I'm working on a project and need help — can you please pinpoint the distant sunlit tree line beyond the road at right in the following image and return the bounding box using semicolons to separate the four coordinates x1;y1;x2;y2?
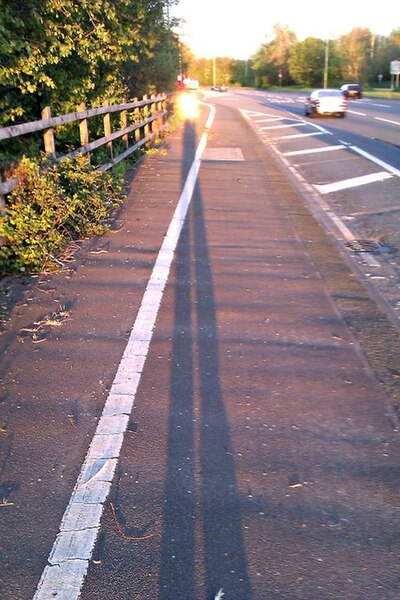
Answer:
189;24;400;88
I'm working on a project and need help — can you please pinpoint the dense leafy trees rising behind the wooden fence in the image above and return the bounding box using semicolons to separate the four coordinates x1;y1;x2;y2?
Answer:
0;0;179;126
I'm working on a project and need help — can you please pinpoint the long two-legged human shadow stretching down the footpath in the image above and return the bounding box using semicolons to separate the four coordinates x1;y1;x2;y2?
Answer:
159;122;253;600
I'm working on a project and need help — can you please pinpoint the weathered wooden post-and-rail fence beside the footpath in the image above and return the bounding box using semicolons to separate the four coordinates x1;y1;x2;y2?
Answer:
0;94;167;214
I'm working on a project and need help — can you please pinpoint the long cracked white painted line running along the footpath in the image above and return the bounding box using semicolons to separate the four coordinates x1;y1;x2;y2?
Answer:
34;105;215;600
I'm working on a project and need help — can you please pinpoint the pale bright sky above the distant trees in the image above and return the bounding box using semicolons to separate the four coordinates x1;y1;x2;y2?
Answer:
171;0;400;59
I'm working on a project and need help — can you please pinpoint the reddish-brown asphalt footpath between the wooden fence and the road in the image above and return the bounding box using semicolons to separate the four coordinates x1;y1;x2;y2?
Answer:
0;99;400;600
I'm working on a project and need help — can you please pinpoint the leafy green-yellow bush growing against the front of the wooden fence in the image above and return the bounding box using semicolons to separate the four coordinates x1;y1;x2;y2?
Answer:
0;154;123;275
